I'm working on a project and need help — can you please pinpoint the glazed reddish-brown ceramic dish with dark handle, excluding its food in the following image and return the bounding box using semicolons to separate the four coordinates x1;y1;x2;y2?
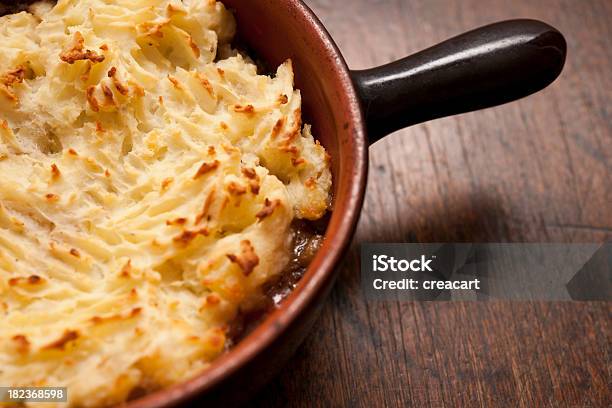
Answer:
119;0;566;408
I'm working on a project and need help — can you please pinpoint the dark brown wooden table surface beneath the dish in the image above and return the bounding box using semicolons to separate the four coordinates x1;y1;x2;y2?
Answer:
253;0;612;407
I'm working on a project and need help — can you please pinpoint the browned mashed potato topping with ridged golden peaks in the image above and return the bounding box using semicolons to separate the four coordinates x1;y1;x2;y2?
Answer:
0;0;331;406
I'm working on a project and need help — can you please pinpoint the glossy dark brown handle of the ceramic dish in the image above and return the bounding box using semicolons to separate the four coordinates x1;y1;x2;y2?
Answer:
351;20;567;143
